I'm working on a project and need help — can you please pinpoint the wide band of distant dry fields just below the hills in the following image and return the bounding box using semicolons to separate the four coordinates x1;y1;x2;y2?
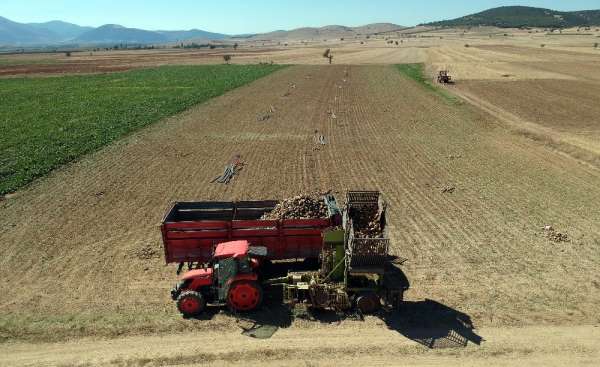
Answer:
0;27;600;75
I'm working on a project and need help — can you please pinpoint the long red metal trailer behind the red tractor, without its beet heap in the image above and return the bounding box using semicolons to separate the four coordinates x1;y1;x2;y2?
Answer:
161;196;342;264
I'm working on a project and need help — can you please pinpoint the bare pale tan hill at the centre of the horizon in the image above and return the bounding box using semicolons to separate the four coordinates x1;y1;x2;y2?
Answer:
250;23;406;40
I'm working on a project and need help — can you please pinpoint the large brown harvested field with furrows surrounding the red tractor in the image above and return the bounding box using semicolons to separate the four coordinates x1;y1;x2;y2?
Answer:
0;65;600;364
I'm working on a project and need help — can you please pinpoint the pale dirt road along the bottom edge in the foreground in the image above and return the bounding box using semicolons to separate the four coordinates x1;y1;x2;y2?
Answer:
0;325;600;367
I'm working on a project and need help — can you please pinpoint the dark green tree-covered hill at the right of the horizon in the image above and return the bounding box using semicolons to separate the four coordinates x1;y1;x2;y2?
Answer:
425;6;600;28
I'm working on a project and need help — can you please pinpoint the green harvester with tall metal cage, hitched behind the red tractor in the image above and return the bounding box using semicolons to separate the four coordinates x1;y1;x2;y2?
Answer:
271;191;406;313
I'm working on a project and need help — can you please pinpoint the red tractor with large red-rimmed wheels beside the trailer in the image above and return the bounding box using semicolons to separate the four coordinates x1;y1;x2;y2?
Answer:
171;241;267;317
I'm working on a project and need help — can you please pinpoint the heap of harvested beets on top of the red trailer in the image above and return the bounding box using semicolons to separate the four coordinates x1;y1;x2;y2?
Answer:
262;195;327;220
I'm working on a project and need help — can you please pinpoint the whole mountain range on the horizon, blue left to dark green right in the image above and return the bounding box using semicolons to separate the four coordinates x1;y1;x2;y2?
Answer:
0;6;600;47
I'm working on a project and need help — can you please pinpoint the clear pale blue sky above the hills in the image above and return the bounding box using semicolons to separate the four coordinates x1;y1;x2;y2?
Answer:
0;0;600;34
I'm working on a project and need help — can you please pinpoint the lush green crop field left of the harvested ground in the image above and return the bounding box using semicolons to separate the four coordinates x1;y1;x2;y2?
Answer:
0;65;282;195
